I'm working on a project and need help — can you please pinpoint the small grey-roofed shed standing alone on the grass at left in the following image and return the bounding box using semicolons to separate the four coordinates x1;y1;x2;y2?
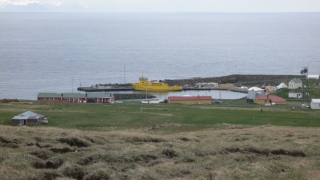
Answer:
12;111;48;126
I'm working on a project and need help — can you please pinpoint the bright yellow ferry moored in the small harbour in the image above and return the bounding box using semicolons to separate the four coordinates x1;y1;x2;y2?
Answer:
132;74;182;91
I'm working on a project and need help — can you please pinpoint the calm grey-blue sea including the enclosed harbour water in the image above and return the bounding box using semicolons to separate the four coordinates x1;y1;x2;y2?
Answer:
0;12;320;100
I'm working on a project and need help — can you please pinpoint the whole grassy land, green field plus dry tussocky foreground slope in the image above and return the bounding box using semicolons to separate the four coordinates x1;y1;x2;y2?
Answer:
0;103;320;180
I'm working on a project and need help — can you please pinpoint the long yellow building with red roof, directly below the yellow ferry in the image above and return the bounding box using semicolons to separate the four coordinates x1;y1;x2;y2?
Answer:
168;96;213;104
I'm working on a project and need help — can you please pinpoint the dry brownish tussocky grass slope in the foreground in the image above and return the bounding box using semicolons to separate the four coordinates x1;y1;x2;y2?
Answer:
0;124;320;180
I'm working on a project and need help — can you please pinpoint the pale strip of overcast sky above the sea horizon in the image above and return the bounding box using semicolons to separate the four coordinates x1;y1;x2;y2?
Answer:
0;0;320;12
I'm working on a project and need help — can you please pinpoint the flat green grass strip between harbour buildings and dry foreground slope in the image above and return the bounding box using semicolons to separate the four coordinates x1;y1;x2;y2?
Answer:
0;104;320;131
